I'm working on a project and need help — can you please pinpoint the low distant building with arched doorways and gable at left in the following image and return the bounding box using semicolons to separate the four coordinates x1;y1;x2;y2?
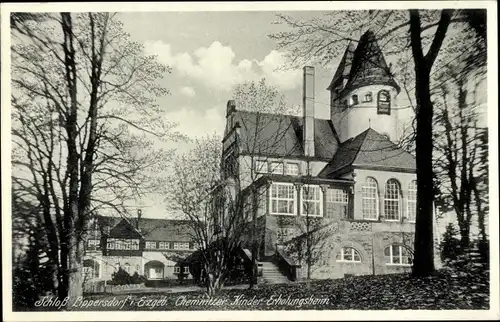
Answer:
83;214;196;282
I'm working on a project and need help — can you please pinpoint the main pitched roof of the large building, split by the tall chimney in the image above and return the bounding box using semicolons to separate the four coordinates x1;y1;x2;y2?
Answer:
234;111;338;161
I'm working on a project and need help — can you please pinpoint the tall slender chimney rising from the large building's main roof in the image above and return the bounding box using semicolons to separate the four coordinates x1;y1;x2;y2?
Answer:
302;66;314;157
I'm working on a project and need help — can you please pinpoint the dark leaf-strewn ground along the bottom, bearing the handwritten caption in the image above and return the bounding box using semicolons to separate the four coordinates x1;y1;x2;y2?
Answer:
72;270;489;311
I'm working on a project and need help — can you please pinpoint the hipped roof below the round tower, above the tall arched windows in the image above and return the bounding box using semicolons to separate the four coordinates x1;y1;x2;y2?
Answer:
318;128;416;178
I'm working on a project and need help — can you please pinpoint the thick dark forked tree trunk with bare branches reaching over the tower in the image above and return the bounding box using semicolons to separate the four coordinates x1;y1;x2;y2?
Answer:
271;9;484;276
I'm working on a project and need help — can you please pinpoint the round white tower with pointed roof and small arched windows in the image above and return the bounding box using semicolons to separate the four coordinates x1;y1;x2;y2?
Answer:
327;30;401;142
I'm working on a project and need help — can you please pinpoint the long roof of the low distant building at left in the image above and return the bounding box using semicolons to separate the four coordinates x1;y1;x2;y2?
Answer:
110;218;192;242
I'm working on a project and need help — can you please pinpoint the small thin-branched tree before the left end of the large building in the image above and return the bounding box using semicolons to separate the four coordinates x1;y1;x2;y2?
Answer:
168;135;248;296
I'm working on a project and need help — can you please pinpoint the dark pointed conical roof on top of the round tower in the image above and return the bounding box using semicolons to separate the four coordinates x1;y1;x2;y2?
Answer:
345;30;400;92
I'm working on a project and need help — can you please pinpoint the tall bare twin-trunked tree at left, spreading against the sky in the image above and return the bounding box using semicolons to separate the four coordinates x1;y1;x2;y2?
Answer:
11;13;177;299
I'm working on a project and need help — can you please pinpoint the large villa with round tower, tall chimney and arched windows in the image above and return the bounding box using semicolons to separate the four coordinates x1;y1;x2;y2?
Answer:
222;31;440;278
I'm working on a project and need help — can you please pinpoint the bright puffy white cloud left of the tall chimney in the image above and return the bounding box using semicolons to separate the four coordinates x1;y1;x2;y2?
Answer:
145;41;301;91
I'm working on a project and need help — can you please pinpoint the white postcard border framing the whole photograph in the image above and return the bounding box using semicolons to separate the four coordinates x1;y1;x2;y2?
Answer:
1;1;500;321
